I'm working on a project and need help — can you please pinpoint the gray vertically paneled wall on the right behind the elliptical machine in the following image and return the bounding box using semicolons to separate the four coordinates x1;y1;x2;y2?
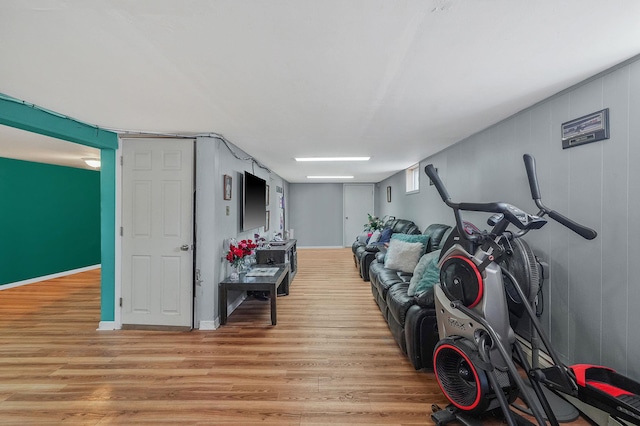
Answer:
378;55;640;380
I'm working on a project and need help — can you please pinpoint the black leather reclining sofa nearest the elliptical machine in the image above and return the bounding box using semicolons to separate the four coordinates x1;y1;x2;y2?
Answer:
369;224;452;370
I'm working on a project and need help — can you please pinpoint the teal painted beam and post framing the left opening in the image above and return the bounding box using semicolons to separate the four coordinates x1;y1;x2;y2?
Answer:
0;94;118;321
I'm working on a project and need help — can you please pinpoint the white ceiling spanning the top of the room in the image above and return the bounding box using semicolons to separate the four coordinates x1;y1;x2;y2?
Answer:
0;0;640;182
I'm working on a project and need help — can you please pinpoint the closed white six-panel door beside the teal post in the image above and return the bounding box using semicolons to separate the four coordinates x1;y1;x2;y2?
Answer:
121;139;194;328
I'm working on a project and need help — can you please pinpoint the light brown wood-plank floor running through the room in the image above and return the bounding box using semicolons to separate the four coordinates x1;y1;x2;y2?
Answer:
0;249;592;425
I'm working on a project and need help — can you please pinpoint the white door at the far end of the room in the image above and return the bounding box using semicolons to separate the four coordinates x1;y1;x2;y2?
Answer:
343;184;374;247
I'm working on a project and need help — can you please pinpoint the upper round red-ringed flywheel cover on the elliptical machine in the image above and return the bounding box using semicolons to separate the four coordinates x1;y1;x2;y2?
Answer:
440;256;484;308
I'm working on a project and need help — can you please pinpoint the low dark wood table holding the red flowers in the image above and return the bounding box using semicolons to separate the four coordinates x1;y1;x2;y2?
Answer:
218;264;290;325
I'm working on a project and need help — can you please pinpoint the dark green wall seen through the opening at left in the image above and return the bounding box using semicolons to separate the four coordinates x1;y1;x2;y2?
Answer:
0;158;100;285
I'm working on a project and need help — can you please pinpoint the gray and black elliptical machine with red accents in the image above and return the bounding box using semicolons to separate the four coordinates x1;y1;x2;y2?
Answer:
425;154;640;425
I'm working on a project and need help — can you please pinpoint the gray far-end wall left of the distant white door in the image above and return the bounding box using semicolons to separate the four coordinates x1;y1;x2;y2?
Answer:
287;183;343;247
